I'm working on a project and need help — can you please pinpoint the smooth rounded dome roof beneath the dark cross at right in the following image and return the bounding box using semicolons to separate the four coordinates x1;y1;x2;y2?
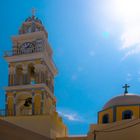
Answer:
103;93;140;109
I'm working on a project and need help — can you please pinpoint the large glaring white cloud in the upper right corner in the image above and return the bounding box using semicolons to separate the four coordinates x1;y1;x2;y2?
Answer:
111;0;140;60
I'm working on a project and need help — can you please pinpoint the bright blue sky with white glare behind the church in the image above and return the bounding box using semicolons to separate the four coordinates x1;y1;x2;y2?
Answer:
0;0;140;134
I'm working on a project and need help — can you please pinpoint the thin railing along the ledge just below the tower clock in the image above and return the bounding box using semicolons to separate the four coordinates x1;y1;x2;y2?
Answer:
4;47;43;57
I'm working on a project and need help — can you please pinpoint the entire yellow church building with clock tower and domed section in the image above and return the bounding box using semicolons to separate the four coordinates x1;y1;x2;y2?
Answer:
0;14;140;140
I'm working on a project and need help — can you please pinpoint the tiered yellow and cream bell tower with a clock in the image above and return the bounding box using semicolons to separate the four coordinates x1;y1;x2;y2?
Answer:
4;14;57;116
